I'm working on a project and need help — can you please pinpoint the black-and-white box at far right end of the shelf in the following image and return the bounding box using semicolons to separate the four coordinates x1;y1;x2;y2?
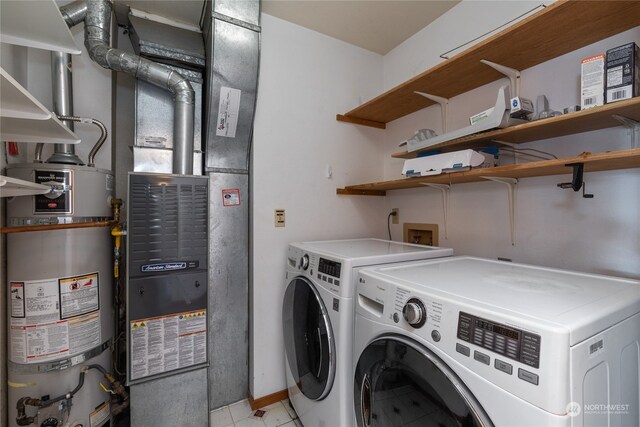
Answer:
606;43;640;104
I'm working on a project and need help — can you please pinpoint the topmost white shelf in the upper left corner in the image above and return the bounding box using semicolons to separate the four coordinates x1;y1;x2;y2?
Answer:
0;0;81;55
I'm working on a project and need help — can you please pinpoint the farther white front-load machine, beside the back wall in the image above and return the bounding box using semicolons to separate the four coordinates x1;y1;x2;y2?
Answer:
282;239;453;427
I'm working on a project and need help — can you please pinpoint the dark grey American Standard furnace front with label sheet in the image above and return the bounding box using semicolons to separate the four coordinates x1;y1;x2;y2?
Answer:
127;173;208;384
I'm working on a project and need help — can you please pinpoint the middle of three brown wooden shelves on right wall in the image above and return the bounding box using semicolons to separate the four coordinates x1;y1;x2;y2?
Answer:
391;98;640;159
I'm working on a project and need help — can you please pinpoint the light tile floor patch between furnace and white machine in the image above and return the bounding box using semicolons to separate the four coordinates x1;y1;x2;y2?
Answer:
209;399;302;427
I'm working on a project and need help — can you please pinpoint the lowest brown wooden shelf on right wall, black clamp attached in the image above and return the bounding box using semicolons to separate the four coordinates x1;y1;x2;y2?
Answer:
337;148;640;196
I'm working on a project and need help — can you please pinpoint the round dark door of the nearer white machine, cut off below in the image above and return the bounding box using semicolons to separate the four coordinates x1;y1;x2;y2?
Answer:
354;335;493;427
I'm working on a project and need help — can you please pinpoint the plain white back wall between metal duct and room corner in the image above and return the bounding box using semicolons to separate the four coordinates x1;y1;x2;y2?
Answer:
250;14;386;398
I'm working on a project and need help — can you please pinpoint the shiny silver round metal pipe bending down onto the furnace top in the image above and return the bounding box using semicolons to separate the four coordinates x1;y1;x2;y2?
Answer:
60;0;195;175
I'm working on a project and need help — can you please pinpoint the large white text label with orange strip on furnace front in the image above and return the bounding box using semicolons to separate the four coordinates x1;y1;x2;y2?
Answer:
130;310;207;380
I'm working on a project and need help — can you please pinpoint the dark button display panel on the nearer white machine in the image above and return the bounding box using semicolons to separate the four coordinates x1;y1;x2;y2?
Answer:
458;312;540;368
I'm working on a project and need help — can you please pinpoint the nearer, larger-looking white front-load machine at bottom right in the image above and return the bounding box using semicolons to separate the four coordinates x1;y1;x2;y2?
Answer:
354;257;640;427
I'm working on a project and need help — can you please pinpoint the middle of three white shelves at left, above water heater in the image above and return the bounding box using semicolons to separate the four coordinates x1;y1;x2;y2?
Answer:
0;68;80;144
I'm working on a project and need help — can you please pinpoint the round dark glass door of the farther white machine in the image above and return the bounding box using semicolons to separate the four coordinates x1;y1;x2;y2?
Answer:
282;277;336;400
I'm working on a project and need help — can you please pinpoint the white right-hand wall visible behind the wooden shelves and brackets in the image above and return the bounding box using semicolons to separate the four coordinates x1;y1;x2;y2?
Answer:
384;1;640;278
